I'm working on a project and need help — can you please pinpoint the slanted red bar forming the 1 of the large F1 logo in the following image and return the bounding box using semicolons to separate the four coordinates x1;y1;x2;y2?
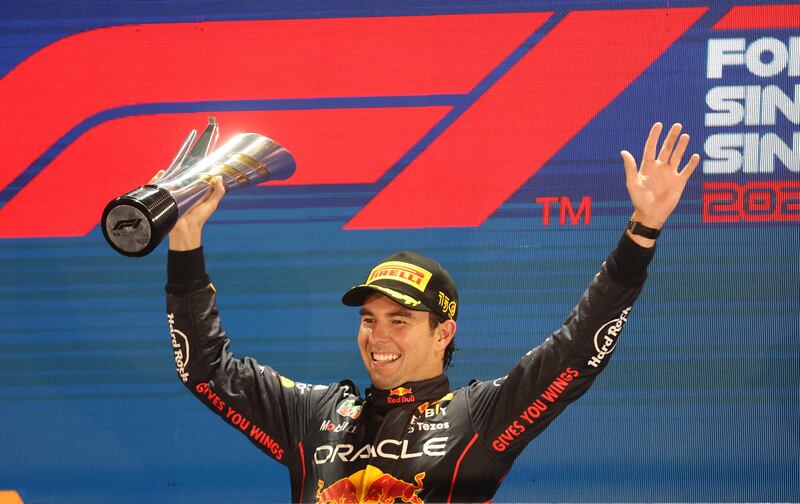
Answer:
345;8;706;229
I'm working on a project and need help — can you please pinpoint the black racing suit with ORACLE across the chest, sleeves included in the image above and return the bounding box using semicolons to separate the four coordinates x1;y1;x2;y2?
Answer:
167;235;653;504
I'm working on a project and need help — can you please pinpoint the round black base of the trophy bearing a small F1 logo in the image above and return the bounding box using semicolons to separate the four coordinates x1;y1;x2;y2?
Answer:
101;185;178;257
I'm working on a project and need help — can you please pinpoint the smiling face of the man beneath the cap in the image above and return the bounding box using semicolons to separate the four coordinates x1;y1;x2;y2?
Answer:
358;293;447;389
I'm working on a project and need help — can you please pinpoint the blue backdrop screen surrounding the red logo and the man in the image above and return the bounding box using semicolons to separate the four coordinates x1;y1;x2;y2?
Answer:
0;0;800;503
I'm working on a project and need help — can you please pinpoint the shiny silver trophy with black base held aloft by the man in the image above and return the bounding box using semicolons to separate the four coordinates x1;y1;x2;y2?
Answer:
101;117;295;257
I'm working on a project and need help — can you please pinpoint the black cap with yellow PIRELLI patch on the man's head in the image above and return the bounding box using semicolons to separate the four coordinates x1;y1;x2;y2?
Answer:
342;251;458;320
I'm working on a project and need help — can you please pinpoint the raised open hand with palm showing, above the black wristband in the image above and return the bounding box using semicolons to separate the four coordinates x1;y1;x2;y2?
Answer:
620;122;700;229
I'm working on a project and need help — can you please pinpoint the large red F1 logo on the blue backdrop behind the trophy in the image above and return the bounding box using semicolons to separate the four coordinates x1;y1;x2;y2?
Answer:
0;7;792;238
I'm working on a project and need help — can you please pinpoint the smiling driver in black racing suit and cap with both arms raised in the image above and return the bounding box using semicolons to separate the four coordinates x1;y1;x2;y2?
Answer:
167;123;699;503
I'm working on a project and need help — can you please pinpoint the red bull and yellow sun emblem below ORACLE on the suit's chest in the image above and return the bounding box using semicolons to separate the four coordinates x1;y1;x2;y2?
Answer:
317;465;425;504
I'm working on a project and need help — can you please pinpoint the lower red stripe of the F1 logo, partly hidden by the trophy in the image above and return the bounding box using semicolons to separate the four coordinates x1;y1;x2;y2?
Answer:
0;107;449;238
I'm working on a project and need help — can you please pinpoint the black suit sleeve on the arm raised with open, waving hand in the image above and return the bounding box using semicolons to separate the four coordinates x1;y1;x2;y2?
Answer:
467;234;654;460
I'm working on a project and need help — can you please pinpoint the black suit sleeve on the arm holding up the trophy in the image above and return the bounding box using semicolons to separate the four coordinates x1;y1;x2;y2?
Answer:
166;249;326;465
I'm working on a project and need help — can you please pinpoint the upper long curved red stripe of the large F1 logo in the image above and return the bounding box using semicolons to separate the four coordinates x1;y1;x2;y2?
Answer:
0;13;542;195
